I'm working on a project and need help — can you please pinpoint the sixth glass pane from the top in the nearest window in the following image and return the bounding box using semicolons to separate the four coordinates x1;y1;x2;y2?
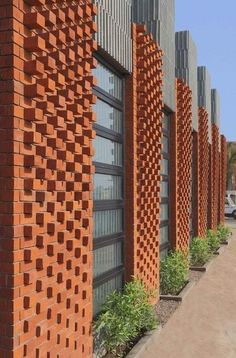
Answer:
93;242;123;278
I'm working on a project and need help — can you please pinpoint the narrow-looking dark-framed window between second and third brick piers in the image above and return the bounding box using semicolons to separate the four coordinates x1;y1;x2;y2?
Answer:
160;112;170;257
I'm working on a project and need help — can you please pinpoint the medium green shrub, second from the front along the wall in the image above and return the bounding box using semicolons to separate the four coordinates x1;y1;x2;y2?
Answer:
160;251;189;295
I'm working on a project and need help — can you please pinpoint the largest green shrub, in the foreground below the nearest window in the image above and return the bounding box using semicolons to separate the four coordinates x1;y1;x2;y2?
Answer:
94;279;157;357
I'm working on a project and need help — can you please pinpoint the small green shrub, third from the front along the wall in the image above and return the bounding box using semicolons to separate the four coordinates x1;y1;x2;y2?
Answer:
190;237;210;266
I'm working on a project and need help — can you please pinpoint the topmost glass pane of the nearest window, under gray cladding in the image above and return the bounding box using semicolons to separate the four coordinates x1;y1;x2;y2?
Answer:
94;63;123;101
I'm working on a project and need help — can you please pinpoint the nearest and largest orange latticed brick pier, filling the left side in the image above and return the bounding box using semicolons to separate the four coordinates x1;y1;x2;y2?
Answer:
0;0;95;358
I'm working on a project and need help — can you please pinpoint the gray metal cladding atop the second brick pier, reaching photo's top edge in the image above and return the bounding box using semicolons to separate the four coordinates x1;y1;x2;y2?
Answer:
133;0;175;111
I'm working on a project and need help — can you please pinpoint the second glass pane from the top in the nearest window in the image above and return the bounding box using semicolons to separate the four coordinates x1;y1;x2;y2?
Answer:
93;99;122;134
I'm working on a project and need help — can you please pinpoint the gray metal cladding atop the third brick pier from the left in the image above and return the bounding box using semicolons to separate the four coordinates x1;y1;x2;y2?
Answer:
175;31;198;131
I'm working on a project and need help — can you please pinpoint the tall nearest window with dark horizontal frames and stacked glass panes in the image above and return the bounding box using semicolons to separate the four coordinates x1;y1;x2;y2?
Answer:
93;62;124;315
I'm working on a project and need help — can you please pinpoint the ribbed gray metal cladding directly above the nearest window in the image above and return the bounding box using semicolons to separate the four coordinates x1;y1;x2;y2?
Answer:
93;0;132;72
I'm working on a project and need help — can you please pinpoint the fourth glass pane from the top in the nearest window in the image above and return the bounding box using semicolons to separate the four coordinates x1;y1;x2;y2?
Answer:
93;174;123;200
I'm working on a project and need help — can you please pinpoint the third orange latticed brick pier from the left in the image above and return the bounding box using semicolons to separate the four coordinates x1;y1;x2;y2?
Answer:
170;79;193;252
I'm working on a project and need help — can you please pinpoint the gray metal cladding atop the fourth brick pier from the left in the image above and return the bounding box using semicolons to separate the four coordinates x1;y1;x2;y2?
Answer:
197;66;212;143
